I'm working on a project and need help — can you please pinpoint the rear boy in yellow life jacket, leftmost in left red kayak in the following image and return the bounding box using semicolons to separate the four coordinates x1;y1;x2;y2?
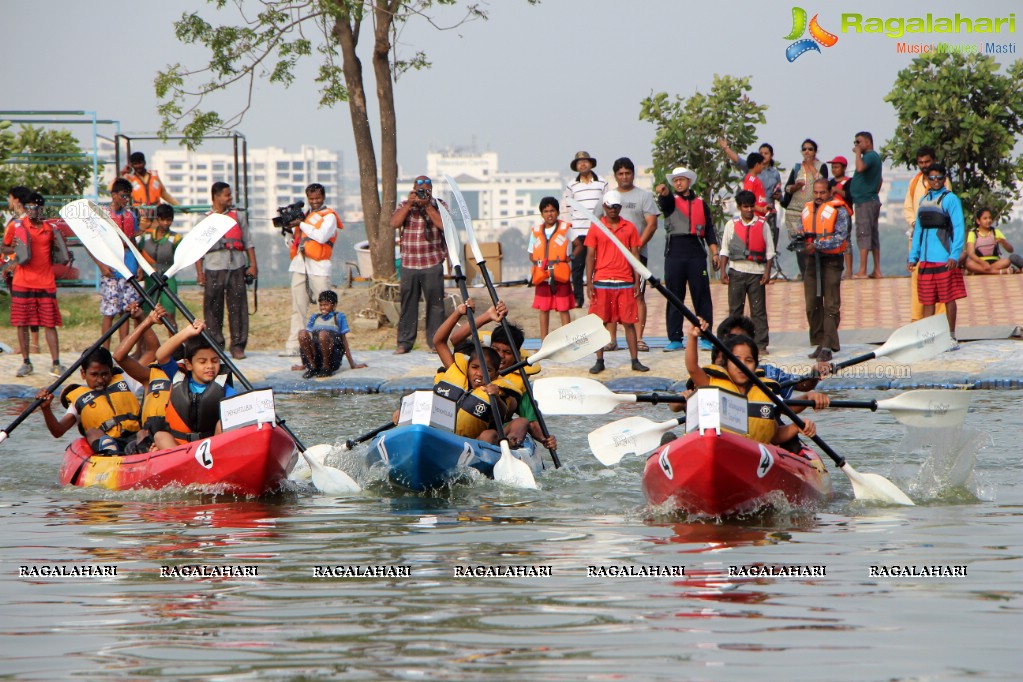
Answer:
36;347;142;455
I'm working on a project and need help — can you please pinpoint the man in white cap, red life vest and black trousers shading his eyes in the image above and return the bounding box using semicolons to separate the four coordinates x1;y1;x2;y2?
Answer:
655;166;718;353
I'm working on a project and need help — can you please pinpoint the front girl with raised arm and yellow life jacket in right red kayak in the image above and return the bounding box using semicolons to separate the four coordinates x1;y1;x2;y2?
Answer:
685;319;828;445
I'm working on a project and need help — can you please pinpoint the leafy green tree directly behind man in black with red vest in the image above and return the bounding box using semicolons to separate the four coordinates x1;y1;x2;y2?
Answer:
639;75;767;222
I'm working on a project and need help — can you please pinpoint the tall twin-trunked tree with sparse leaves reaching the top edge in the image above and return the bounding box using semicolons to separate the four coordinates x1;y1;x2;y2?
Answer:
154;0;539;277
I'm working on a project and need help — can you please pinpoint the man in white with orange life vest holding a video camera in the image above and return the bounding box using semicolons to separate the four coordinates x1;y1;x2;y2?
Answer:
282;182;344;356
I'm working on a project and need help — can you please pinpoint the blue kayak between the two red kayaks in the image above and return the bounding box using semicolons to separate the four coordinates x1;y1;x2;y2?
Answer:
366;424;543;493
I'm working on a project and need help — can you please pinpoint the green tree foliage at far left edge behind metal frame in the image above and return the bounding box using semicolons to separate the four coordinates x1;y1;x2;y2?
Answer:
0;122;92;204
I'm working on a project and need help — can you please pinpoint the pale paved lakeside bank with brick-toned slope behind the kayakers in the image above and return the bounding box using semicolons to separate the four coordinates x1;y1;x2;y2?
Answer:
0;275;1023;398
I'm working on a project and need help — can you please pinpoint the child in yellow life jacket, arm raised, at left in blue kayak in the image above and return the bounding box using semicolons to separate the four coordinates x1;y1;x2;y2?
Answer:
434;300;519;444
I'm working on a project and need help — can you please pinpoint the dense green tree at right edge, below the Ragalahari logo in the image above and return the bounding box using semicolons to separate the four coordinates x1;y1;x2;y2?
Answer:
884;52;1023;223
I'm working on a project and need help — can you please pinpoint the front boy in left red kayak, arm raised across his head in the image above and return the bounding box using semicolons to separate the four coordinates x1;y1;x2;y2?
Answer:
142;319;237;450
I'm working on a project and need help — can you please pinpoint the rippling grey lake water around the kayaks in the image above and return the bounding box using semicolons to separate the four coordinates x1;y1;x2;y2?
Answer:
0;392;1023;682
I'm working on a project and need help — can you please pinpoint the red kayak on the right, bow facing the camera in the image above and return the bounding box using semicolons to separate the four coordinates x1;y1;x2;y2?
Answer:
642;430;831;516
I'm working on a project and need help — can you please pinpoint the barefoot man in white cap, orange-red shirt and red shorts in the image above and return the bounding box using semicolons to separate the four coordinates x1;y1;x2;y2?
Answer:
585;189;650;374
